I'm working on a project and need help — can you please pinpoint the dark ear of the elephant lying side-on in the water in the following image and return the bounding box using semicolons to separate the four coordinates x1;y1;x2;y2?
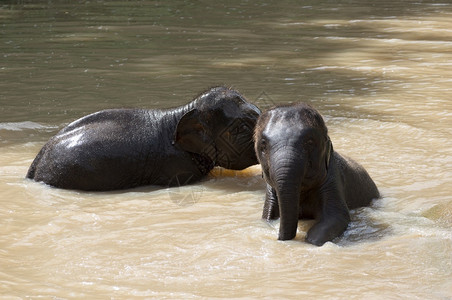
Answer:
174;109;213;154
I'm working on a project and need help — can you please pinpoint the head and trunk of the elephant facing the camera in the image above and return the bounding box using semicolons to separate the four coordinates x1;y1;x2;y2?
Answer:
255;103;333;240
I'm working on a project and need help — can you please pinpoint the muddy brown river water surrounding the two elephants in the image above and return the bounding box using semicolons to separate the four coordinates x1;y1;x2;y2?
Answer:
0;0;452;299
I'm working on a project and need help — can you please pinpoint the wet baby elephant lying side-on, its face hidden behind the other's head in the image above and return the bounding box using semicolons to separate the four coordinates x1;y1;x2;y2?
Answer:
27;87;260;191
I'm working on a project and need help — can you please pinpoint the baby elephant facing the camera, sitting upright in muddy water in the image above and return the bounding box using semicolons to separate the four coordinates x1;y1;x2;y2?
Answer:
255;103;379;246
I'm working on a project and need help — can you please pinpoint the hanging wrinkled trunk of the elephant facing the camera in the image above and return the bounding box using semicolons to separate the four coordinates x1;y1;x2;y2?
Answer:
273;153;305;240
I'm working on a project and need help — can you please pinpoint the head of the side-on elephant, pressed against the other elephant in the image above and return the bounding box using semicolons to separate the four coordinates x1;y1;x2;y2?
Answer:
175;87;261;170
